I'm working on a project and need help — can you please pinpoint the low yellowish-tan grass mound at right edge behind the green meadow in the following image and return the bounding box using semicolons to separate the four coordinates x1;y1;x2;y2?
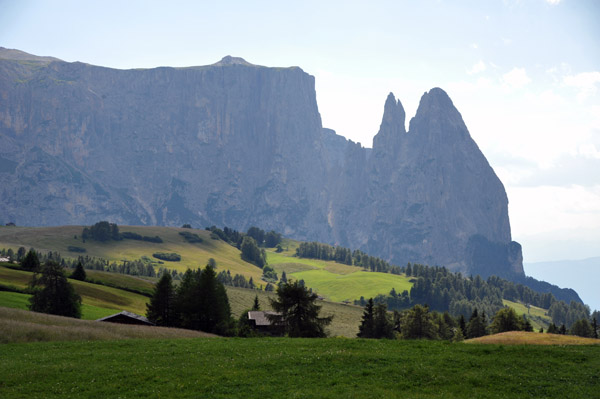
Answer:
465;331;600;345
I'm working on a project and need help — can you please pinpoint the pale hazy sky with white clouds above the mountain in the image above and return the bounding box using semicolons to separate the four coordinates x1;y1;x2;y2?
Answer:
0;0;600;262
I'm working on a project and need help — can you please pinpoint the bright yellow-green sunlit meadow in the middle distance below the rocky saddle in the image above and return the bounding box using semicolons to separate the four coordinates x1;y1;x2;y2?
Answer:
267;248;412;302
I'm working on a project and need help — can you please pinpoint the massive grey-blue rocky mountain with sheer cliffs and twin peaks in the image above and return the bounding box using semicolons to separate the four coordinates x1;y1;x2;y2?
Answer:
0;48;523;276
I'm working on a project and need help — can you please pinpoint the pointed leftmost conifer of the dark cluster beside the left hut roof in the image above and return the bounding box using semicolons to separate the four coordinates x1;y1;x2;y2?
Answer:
146;273;177;327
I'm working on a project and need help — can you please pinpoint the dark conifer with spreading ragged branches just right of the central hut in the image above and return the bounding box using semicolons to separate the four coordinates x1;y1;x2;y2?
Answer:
267;281;333;338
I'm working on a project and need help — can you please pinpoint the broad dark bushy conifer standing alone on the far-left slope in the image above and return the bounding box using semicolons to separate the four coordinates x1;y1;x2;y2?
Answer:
29;261;81;319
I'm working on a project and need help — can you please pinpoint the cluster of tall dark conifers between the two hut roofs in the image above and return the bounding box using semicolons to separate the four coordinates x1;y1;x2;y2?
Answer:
146;265;235;335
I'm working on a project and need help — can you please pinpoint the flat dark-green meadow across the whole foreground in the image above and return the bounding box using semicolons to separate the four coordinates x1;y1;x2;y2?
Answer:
0;338;600;399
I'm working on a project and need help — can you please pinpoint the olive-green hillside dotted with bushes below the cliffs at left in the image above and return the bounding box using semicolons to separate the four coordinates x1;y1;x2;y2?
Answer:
0;226;262;281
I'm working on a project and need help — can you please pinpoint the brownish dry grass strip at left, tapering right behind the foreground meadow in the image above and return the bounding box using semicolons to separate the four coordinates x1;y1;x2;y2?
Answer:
0;306;214;344
